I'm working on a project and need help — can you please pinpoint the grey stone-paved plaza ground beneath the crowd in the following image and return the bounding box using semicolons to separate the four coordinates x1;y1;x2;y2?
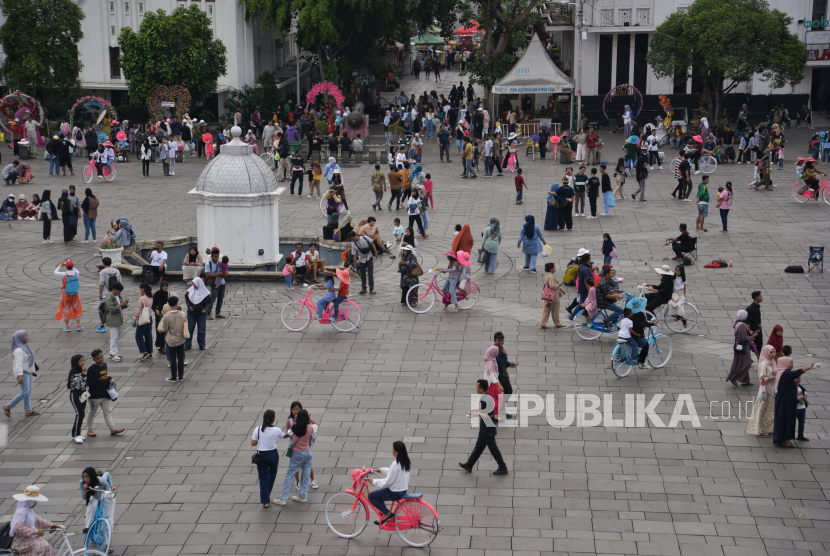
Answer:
0;72;830;556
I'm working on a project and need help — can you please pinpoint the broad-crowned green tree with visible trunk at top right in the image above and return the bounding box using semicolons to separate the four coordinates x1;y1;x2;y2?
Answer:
647;0;807;125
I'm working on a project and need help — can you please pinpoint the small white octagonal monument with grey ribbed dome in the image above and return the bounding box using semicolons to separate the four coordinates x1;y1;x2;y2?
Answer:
188;126;285;270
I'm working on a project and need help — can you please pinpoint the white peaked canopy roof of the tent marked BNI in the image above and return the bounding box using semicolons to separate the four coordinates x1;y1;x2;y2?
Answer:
492;36;574;95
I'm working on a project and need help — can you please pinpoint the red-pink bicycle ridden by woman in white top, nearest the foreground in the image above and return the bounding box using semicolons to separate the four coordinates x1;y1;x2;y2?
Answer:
326;467;440;548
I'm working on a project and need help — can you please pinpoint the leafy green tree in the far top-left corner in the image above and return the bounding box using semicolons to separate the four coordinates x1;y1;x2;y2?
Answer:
0;0;85;100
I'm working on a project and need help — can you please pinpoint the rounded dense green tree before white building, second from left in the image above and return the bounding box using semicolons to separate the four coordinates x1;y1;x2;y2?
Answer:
118;4;228;105
